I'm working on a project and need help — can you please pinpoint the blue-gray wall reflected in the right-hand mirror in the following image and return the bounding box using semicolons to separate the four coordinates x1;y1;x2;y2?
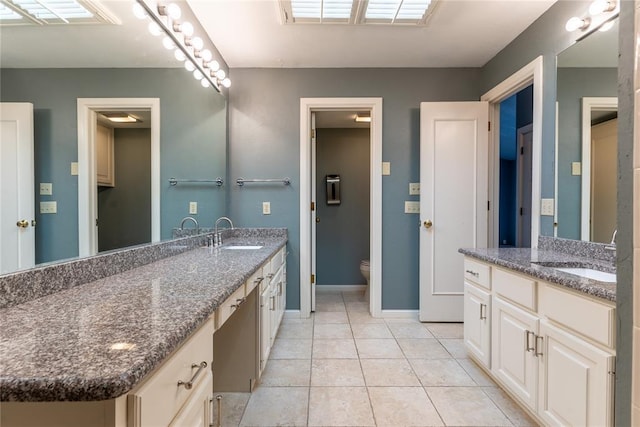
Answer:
558;68;618;240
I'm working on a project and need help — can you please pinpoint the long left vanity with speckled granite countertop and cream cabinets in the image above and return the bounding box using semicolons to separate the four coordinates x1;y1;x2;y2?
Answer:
0;229;287;427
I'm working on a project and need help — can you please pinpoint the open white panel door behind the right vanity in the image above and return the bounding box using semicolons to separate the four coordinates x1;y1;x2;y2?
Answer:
420;102;489;322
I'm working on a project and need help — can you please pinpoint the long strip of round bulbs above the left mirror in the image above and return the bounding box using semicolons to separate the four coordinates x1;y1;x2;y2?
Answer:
133;0;231;92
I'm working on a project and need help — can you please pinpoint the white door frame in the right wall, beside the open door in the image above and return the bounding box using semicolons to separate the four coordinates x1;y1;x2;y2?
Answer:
480;55;543;248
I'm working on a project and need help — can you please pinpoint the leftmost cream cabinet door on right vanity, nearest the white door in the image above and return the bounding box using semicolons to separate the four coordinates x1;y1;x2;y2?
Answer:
464;282;491;368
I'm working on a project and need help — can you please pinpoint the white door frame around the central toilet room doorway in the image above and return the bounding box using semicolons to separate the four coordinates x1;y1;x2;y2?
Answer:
300;98;382;318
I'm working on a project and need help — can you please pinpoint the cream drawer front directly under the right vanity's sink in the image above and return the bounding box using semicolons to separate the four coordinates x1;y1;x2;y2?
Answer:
540;284;616;348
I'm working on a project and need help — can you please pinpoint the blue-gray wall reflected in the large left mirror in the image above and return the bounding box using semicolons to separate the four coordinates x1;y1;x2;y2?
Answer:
0;68;227;263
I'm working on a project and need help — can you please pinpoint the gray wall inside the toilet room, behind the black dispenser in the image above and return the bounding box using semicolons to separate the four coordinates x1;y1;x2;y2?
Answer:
316;129;371;286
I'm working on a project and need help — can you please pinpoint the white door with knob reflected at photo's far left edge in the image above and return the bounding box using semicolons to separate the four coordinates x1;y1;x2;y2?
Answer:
0;102;35;274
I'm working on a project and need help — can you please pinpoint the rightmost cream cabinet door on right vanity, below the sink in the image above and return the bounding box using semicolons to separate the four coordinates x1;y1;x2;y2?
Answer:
538;321;615;426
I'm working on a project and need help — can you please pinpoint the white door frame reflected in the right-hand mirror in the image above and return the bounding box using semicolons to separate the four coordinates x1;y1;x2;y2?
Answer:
580;96;618;241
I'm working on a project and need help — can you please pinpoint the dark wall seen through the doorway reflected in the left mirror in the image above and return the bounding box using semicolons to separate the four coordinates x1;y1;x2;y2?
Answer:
98;128;151;252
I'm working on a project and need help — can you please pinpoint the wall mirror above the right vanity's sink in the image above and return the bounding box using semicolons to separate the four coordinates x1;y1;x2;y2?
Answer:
556;20;618;243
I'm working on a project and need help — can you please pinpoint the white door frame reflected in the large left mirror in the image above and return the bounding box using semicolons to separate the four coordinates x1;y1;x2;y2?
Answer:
77;98;160;257
